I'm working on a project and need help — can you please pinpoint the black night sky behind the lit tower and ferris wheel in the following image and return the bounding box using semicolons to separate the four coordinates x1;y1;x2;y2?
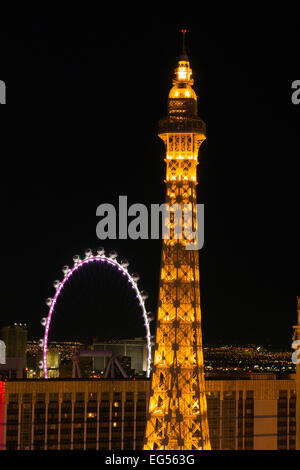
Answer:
0;1;300;348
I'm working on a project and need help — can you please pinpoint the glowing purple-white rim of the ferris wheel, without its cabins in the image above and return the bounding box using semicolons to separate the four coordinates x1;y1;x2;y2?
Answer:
41;254;152;379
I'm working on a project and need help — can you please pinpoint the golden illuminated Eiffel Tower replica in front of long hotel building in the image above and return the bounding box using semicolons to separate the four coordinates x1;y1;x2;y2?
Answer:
144;30;211;450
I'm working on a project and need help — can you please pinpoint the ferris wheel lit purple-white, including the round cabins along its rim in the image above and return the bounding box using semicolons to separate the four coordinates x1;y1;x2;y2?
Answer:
39;247;153;378
